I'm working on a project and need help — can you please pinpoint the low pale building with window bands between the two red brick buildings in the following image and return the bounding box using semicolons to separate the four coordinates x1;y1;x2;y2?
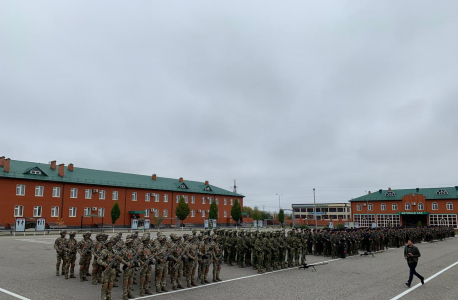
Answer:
292;203;351;227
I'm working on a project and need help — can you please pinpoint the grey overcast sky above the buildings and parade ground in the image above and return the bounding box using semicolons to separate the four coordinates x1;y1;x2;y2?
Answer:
0;0;458;211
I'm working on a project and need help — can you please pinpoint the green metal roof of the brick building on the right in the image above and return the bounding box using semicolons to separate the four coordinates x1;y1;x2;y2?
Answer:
350;186;458;202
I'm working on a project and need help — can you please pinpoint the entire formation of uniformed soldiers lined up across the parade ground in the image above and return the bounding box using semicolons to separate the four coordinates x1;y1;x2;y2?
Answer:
54;227;455;300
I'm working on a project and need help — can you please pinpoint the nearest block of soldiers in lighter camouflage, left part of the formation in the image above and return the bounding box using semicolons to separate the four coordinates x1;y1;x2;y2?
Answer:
54;231;223;300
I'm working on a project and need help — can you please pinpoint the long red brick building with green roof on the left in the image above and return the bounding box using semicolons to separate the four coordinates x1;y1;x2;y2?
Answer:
0;156;244;227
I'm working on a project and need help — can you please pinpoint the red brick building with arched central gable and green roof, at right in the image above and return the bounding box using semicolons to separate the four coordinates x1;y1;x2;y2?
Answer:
350;186;458;228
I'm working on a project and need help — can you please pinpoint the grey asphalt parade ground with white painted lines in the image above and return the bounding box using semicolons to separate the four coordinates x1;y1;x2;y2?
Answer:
0;236;458;300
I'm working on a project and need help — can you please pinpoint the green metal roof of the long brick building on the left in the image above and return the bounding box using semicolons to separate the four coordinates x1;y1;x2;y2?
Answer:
0;160;244;197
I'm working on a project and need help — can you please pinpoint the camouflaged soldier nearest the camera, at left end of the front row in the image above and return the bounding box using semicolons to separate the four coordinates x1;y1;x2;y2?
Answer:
97;237;121;300
